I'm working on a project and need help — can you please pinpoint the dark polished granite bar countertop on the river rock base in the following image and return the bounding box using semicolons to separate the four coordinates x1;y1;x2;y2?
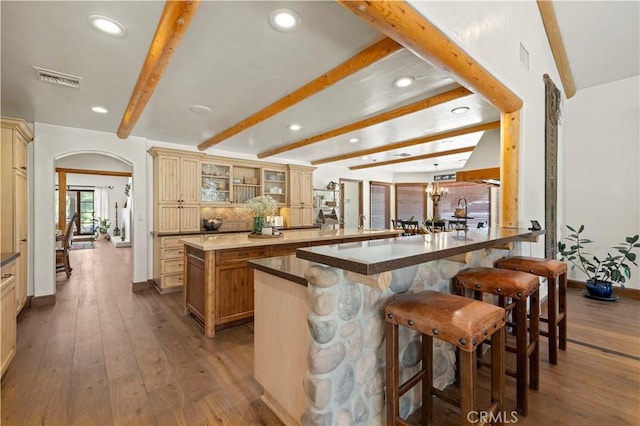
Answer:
296;228;545;275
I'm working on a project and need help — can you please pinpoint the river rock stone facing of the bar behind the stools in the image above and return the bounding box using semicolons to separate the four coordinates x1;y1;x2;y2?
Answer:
301;245;509;426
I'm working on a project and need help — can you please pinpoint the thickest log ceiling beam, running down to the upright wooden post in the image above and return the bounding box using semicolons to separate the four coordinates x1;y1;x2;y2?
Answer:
337;0;522;112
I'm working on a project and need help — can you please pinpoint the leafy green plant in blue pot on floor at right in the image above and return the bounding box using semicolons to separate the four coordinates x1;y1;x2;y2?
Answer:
558;225;640;300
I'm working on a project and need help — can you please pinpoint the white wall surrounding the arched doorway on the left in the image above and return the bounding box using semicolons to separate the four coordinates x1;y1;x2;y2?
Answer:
29;122;151;296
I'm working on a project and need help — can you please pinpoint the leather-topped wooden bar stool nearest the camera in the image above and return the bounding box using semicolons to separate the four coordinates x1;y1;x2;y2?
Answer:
385;291;505;426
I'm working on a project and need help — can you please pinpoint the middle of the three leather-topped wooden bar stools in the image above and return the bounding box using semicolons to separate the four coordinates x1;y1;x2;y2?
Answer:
453;268;540;416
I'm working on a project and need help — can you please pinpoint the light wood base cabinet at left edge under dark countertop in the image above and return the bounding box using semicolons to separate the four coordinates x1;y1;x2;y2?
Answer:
0;263;16;375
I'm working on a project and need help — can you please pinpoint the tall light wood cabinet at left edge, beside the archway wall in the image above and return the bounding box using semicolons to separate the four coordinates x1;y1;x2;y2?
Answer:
0;117;33;315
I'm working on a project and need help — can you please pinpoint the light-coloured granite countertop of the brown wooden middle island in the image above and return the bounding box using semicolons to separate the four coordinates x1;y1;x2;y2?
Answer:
181;228;401;251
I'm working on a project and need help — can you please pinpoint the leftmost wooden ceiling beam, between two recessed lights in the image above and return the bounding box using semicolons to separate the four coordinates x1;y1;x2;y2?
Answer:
117;0;201;139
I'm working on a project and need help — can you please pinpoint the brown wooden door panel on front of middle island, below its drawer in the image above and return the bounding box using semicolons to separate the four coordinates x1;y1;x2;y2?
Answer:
215;262;253;324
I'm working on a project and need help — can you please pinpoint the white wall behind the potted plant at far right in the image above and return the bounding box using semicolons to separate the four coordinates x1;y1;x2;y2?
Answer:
560;76;640;288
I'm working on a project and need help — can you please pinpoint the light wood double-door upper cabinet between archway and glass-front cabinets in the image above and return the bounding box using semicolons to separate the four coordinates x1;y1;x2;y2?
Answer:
149;148;201;232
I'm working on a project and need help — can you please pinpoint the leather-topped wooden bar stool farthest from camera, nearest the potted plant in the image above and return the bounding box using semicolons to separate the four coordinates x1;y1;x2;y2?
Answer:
496;256;567;365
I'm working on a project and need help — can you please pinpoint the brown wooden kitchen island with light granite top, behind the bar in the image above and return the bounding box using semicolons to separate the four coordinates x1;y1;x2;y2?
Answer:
180;228;400;337
